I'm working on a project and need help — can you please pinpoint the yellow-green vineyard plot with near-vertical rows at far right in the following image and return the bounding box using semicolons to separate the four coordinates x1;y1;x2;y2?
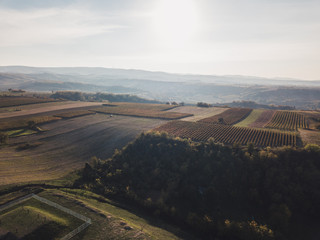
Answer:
265;111;309;131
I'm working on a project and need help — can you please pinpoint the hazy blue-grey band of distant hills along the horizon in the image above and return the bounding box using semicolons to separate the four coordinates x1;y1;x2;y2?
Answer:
0;66;320;109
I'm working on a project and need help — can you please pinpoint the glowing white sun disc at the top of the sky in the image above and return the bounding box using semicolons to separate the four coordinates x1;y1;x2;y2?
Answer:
154;0;198;47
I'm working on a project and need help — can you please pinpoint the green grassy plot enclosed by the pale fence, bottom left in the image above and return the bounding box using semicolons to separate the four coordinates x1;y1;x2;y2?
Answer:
0;196;83;239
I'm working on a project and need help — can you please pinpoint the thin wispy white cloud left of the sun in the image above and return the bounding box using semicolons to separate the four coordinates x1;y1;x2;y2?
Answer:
0;8;124;47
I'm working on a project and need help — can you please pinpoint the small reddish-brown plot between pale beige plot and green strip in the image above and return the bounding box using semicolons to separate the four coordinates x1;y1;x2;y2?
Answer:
199;108;252;125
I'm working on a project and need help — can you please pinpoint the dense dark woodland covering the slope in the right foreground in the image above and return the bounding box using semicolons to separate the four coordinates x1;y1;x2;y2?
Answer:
75;133;320;239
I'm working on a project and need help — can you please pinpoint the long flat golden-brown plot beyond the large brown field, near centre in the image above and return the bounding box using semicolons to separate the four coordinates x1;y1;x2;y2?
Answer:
92;103;192;120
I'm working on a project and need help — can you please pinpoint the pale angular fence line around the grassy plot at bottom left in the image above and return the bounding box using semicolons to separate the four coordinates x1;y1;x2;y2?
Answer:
0;193;92;240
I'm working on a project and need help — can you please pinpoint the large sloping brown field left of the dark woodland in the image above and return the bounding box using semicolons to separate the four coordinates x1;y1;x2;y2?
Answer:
0;114;164;185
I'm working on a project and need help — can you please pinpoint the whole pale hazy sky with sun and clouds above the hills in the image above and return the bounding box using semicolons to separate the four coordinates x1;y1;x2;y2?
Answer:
0;0;320;80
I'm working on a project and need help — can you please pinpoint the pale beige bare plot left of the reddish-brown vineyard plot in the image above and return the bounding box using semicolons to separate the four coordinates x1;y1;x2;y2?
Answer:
168;106;229;122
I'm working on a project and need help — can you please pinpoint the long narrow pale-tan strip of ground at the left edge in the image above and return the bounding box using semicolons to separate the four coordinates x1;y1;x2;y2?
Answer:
0;102;102;118
